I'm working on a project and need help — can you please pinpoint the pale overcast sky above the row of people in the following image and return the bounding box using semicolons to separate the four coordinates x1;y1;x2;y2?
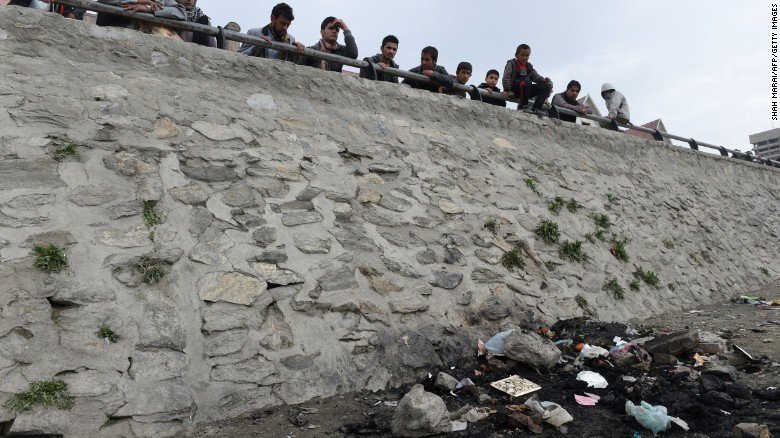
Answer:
198;0;768;150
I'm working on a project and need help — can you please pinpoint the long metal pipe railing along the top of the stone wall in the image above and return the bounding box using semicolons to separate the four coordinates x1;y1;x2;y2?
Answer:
29;0;780;168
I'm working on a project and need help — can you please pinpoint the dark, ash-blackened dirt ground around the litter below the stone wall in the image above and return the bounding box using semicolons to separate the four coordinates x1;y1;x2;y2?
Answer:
193;303;780;438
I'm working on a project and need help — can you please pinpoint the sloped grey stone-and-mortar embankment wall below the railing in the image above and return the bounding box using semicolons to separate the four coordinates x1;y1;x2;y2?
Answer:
0;7;780;436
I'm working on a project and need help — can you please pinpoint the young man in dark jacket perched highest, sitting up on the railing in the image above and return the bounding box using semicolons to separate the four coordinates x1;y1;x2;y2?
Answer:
503;44;552;116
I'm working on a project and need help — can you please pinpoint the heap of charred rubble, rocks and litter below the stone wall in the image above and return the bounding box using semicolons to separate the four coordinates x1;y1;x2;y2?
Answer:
392;318;780;437
